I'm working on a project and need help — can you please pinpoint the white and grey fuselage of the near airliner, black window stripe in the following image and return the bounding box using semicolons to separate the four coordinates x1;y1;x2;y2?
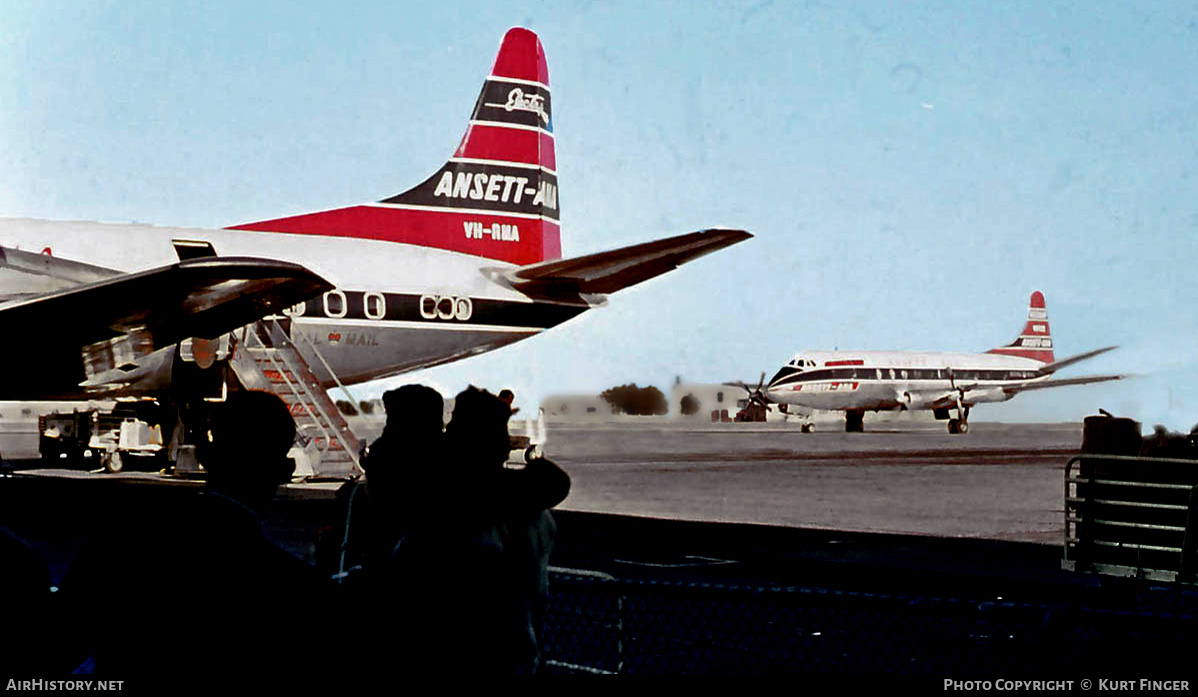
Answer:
0;219;575;384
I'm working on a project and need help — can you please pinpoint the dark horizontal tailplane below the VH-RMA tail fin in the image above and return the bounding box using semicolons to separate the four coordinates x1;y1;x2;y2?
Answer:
484;229;752;298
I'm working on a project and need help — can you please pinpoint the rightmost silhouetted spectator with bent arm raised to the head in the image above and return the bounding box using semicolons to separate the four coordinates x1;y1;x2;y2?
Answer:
395;387;570;673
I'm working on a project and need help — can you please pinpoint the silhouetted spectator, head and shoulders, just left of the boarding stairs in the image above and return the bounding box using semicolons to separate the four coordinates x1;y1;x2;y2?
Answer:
62;392;321;684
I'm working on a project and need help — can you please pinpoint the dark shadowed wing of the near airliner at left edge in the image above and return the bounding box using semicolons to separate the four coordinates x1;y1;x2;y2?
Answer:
0;257;333;399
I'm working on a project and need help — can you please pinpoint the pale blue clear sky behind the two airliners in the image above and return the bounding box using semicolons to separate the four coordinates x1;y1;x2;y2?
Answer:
0;0;1198;431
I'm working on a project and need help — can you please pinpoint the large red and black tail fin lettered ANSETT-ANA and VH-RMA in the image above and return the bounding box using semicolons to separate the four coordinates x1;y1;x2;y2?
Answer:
230;28;562;266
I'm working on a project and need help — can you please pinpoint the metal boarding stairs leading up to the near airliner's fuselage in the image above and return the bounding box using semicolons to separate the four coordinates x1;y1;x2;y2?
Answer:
229;317;362;479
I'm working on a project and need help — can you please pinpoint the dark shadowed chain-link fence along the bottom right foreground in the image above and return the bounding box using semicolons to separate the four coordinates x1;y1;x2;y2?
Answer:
544;569;1198;678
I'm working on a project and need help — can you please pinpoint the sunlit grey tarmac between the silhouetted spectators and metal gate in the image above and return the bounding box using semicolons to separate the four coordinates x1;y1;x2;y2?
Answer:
546;422;1082;544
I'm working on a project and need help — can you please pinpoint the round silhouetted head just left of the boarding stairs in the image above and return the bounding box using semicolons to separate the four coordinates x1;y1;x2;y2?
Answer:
202;392;296;507
